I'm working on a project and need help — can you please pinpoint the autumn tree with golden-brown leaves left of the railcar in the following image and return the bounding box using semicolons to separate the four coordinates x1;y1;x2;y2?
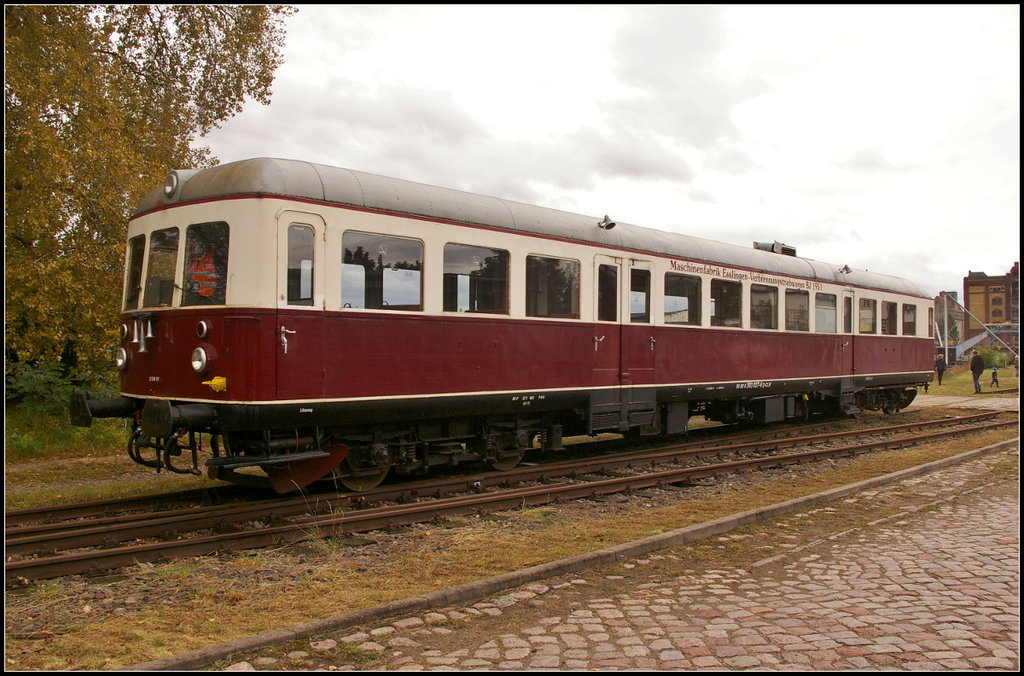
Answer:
4;5;294;393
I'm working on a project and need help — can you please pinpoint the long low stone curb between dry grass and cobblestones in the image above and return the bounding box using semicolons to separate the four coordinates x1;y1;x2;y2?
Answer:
123;438;1019;671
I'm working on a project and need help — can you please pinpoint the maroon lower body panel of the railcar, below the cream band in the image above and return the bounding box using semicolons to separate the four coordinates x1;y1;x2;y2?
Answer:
123;308;932;404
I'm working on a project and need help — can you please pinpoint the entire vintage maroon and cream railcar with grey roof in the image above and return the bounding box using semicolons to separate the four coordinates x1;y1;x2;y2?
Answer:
72;159;933;491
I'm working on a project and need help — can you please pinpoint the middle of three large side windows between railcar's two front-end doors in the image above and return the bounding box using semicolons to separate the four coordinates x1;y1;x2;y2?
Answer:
443;244;509;314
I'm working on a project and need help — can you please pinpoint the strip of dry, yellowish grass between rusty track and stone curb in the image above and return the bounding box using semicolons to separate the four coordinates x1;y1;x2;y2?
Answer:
6;401;1016;670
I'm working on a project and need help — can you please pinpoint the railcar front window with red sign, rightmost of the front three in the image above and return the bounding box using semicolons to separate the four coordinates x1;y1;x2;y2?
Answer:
181;221;228;305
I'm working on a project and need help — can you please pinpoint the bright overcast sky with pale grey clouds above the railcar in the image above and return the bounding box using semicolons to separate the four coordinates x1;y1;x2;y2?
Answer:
201;5;1020;295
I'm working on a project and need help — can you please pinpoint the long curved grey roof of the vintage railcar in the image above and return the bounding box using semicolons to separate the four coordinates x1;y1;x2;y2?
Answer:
135;158;927;298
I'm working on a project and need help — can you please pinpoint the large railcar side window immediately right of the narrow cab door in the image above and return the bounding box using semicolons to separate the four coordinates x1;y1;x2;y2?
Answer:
341;231;421;311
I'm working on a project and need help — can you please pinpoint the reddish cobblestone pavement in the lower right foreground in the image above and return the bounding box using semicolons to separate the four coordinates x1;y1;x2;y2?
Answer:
228;449;1020;671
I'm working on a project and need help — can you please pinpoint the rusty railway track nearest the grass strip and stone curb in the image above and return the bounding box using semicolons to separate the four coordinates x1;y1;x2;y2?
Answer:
5;413;1017;585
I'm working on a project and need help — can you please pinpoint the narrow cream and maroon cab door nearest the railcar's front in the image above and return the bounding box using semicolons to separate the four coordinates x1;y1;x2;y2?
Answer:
274;211;326;400
